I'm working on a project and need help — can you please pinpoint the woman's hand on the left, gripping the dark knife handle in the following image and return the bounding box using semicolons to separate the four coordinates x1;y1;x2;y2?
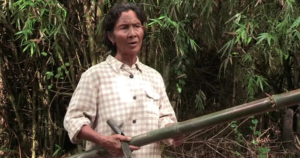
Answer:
100;134;140;157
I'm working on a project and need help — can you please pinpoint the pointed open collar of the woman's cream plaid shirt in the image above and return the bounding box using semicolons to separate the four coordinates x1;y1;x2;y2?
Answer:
105;55;142;73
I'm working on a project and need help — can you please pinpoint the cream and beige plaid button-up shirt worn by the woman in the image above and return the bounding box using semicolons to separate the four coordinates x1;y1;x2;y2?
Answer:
64;56;177;158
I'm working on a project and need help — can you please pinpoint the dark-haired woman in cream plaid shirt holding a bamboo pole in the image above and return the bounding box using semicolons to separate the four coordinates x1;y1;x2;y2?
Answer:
64;3;182;158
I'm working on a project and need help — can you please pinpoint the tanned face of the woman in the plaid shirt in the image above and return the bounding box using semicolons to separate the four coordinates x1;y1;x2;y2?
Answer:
108;10;144;56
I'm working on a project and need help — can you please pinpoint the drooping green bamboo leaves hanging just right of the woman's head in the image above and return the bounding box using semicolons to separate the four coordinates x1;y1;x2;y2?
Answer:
148;6;200;98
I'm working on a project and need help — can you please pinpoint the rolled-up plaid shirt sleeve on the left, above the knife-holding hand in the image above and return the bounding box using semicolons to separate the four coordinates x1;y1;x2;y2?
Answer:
64;71;97;143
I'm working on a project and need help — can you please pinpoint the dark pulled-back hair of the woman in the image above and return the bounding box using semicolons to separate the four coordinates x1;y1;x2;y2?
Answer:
103;3;146;56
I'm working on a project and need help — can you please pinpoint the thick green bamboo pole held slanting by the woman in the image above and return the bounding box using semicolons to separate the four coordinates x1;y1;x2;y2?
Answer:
70;89;300;158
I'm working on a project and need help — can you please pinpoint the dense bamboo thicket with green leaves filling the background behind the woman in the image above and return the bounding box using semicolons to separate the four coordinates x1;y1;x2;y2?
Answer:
0;0;300;158
